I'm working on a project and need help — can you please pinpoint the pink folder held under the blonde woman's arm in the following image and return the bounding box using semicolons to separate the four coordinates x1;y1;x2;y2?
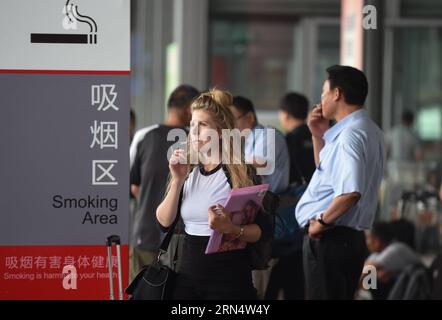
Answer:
205;184;269;254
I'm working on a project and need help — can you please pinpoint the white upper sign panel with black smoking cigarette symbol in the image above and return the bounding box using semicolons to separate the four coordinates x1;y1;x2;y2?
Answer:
0;0;130;71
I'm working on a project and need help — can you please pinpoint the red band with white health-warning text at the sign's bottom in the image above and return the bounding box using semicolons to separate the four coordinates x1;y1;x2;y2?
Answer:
0;244;129;300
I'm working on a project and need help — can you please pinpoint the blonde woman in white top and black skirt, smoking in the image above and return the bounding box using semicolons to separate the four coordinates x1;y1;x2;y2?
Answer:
156;90;263;300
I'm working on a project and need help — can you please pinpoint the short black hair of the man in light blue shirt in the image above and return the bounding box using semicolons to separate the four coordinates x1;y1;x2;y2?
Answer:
327;65;368;106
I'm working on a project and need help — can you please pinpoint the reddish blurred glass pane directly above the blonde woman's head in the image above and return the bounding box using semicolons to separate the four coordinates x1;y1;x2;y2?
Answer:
209;20;297;110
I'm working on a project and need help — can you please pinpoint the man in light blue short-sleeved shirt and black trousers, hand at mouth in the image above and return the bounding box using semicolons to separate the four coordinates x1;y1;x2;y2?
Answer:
296;66;384;299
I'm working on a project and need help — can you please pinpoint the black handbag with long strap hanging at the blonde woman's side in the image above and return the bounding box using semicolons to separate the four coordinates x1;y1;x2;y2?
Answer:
125;190;184;300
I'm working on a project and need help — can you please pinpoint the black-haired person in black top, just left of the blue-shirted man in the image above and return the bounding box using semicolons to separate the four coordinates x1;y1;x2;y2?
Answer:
279;92;316;185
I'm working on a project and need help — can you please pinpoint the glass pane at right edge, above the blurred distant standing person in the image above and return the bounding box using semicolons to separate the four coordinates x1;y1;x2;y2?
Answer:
393;27;442;142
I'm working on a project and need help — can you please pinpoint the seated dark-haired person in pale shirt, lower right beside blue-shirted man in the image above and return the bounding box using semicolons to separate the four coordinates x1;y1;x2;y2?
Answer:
365;222;420;300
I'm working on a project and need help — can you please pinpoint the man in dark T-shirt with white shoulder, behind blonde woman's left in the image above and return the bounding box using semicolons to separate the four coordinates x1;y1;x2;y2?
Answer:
129;85;199;279
